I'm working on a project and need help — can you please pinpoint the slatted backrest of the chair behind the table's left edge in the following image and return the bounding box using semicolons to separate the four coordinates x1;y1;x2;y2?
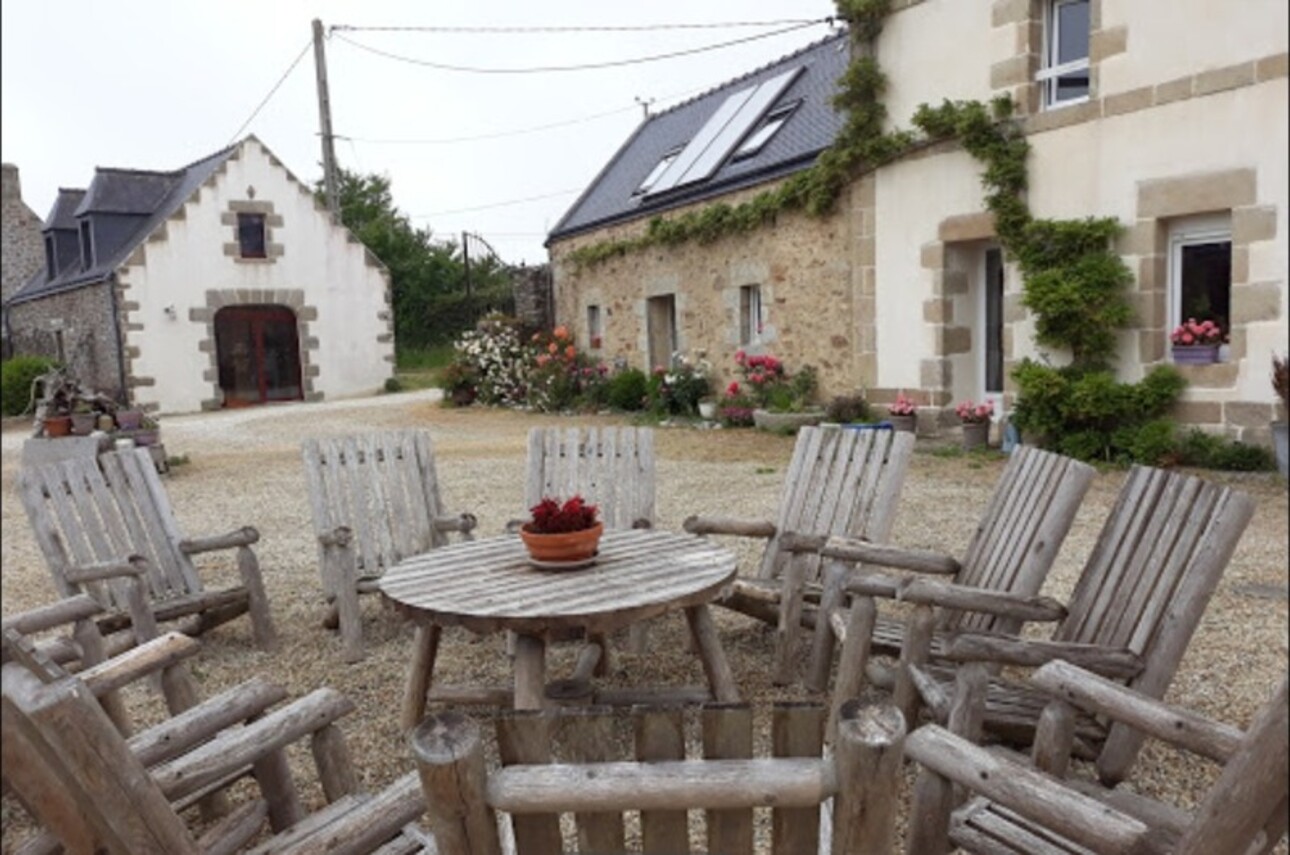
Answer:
302;431;444;576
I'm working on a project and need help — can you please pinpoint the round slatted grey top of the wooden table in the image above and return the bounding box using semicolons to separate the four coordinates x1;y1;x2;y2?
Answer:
379;529;738;634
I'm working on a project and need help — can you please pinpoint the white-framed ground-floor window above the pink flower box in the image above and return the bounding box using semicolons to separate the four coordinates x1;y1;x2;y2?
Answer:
1167;214;1232;358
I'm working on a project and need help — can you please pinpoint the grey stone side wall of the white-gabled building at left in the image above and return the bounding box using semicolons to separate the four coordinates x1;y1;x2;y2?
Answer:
9;282;124;400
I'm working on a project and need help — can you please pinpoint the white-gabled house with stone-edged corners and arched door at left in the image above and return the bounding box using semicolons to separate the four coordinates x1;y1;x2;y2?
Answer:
4;135;393;413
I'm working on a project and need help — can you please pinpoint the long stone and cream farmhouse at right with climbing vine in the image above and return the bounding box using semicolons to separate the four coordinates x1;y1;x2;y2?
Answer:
547;0;1290;444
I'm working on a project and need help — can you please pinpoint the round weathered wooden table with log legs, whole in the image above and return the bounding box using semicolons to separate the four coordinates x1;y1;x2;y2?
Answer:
379;529;738;727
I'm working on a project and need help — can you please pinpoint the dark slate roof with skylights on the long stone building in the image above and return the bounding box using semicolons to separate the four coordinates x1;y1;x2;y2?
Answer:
547;31;850;245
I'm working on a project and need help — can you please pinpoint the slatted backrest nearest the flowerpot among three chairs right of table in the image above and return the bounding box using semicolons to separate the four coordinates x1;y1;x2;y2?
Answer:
757;427;913;580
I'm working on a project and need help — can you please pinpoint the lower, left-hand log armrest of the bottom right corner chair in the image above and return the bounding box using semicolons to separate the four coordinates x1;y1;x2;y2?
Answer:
904;725;1148;852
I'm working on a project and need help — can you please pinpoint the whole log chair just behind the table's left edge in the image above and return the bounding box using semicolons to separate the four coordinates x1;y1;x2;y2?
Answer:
301;431;476;663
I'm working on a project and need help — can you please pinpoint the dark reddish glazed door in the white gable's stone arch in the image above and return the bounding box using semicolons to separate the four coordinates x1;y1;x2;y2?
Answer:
215;306;303;406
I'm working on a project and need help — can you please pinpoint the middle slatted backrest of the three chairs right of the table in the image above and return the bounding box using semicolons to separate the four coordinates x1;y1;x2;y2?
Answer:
940;446;1094;633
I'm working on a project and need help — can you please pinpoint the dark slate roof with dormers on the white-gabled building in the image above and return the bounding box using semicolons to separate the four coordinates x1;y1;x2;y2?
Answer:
8;143;241;304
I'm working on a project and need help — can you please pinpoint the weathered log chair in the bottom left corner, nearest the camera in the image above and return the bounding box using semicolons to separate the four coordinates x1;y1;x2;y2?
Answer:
0;629;435;855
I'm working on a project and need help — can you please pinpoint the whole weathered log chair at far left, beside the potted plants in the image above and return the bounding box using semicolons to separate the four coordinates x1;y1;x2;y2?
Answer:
18;449;277;651
